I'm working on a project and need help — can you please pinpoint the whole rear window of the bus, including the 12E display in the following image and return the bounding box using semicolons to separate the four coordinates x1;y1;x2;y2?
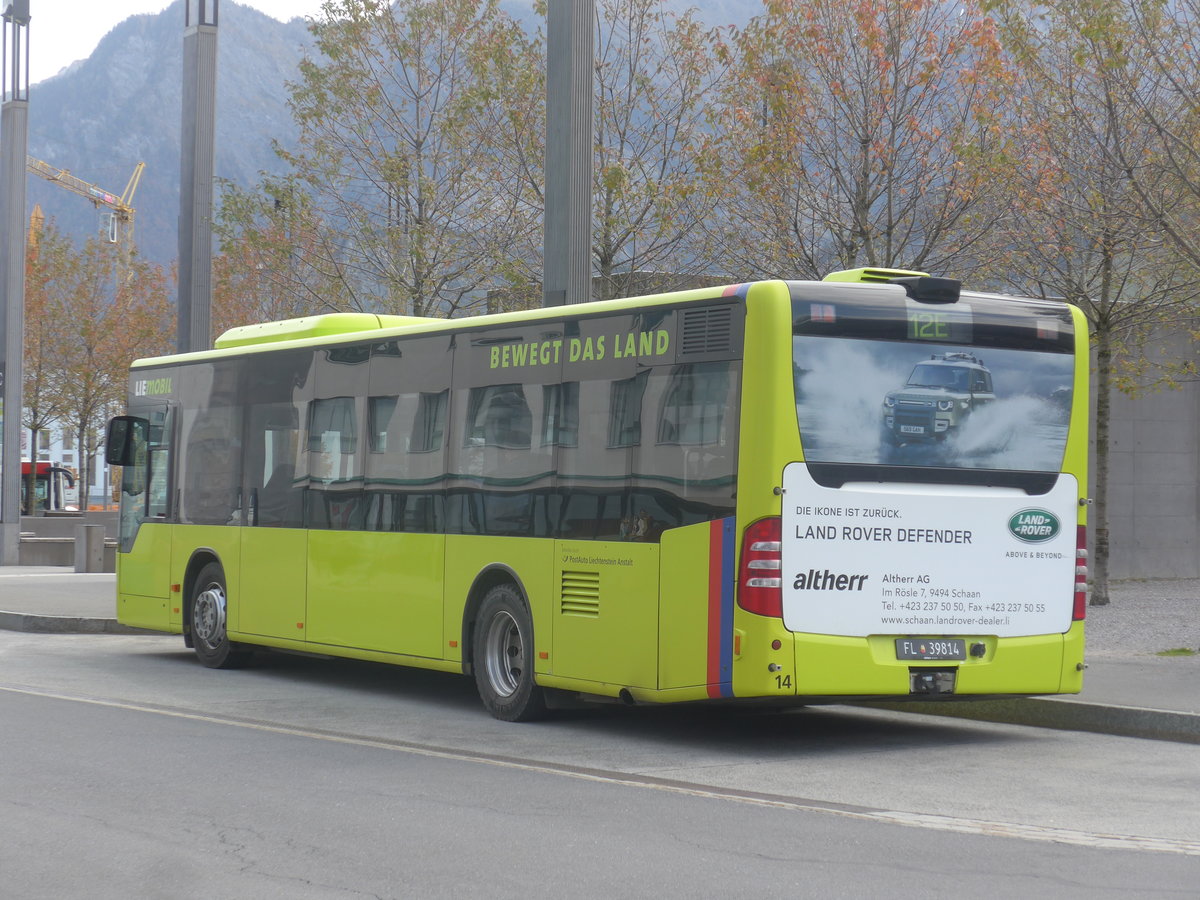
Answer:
792;292;1074;472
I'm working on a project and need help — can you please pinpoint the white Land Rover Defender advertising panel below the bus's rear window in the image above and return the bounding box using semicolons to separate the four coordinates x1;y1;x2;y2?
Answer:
784;463;1078;637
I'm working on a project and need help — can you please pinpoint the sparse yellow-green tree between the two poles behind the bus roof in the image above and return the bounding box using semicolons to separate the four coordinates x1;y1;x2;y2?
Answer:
226;0;536;316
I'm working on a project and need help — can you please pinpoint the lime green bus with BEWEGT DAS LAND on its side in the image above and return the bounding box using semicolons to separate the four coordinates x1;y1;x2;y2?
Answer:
106;269;1087;720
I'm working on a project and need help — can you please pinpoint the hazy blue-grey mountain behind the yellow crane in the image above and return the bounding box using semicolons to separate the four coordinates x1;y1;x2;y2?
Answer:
28;0;312;264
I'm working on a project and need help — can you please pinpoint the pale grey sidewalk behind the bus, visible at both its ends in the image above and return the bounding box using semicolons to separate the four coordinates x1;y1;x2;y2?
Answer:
0;566;1200;743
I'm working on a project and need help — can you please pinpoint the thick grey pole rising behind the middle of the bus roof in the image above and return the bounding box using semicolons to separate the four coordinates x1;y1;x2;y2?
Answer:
541;0;595;306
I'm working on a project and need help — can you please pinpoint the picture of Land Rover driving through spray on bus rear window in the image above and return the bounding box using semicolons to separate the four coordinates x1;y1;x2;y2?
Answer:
793;335;1075;472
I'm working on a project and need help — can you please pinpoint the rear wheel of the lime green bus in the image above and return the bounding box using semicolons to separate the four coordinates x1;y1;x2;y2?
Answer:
472;584;546;722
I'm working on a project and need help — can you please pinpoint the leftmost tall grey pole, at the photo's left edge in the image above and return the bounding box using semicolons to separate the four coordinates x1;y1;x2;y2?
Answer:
0;0;29;565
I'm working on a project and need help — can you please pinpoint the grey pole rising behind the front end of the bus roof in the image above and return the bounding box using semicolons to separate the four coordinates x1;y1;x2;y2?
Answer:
175;0;217;353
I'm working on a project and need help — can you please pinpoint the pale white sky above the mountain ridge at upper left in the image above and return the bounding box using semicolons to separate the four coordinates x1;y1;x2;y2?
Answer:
29;0;320;84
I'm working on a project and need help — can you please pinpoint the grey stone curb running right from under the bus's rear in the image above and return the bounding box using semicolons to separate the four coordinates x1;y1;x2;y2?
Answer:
854;697;1200;744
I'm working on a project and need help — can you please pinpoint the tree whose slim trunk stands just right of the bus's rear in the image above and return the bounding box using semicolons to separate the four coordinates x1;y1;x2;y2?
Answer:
996;0;1200;605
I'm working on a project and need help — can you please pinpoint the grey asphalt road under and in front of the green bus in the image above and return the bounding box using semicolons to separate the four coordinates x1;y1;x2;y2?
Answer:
0;632;1200;898
